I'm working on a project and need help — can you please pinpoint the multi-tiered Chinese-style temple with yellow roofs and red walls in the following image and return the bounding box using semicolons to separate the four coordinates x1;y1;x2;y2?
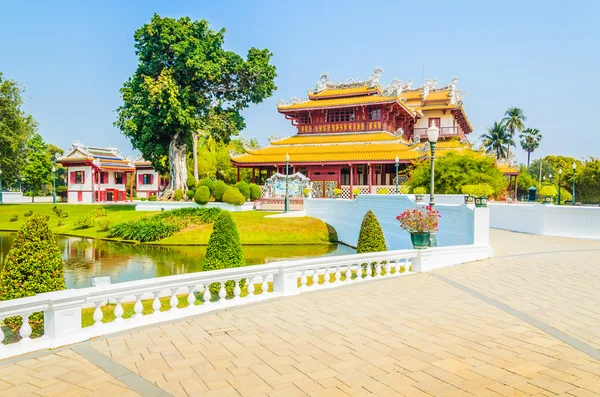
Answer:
231;69;473;198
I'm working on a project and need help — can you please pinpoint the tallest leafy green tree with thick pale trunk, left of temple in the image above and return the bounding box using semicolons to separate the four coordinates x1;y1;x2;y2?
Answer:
115;14;277;199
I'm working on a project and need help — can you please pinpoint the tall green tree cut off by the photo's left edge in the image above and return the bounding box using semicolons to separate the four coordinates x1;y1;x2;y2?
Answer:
0;73;37;184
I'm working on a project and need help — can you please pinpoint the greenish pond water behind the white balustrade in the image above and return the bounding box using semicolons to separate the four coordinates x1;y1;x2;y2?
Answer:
0;232;355;288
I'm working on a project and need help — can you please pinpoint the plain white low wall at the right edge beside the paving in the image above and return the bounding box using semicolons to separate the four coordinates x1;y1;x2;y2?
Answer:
488;203;600;239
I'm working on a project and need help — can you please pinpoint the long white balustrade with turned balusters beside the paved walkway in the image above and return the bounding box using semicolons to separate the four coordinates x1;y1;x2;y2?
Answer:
0;245;493;359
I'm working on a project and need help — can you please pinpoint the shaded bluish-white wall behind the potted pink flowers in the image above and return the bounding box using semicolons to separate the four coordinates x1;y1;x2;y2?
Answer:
304;194;482;250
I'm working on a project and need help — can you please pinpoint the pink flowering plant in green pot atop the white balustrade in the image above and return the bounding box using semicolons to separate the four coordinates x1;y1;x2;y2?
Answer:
396;206;441;249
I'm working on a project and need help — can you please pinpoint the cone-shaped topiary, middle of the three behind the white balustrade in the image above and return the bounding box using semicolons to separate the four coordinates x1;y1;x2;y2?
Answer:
202;211;246;298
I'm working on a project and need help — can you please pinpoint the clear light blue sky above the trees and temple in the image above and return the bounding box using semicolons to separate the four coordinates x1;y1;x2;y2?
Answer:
0;0;600;162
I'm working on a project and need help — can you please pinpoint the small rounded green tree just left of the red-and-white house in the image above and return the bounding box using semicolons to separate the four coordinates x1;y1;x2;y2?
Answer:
23;134;53;202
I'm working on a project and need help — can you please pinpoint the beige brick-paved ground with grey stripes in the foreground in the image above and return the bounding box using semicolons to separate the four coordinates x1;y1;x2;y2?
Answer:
0;230;600;397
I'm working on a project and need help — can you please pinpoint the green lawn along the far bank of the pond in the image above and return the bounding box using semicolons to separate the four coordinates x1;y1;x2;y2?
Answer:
0;204;335;245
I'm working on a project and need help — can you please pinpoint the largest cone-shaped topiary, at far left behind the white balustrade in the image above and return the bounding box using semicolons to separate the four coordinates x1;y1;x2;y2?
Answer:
0;214;66;332
